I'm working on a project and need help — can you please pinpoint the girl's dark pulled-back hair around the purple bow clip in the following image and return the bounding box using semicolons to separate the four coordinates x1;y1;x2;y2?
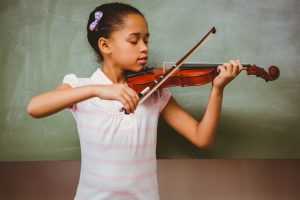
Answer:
87;2;144;62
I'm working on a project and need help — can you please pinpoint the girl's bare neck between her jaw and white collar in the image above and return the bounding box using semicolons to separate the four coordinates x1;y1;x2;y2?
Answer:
102;62;126;84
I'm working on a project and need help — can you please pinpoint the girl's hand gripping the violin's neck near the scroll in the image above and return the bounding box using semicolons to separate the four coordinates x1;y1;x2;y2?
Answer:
213;60;246;90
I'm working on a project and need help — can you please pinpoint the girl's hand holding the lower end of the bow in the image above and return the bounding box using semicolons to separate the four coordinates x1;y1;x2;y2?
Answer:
95;83;139;113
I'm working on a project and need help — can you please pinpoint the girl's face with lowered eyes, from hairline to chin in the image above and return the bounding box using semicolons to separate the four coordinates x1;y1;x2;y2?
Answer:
109;14;149;72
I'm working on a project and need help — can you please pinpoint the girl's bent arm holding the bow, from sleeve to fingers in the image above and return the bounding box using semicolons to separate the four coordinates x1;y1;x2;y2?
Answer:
27;84;139;118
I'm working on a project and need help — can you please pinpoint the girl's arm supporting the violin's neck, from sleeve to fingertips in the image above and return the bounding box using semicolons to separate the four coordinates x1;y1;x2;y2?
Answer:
162;60;244;148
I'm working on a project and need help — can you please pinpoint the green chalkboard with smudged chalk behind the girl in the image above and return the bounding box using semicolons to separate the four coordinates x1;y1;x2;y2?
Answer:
0;0;300;161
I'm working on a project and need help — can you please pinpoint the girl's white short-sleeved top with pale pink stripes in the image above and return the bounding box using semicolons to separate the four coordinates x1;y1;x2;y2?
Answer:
63;68;171;200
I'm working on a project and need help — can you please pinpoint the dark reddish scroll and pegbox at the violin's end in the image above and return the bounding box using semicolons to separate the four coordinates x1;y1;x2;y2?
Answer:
246;65;280;82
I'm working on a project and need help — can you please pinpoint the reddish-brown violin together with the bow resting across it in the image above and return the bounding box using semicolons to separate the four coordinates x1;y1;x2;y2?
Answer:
120;27;280;114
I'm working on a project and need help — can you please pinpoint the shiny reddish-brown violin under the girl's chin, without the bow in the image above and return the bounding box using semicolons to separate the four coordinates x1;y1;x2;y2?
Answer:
126;63;280;94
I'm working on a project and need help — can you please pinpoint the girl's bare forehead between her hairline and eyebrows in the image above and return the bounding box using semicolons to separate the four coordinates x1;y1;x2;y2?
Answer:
112;14;149;36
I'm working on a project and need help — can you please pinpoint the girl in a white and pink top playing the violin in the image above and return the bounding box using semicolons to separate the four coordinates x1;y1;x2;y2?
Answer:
27;3;242;200
